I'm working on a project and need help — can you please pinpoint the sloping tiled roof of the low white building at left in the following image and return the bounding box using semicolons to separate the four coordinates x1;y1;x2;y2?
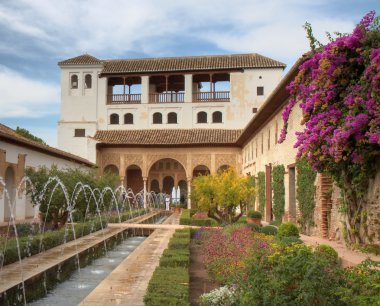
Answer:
0;123;95;166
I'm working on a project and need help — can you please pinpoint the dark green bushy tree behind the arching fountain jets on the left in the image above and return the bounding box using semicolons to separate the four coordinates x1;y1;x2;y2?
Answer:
26;166;119;229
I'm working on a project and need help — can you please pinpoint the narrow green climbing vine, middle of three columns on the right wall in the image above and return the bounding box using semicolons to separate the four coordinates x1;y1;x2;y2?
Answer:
272;165;285;221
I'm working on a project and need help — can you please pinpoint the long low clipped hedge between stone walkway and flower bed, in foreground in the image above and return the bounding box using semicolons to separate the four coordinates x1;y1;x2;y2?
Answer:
144;229;190;306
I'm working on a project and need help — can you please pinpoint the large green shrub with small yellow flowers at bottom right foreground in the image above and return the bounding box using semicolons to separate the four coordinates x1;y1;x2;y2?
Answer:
236;244;341;305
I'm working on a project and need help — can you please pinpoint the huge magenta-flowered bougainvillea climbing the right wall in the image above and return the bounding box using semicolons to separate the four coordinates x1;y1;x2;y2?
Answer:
279;11;380;242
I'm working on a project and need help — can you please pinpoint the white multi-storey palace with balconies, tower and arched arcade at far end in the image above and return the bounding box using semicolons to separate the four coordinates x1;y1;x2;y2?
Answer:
58;54;285;206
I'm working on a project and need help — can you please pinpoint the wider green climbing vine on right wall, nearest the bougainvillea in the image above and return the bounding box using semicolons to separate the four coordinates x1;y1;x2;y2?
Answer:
296;158;317;233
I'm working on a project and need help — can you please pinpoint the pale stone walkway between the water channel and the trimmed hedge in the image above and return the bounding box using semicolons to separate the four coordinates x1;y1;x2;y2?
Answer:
79;213;183;306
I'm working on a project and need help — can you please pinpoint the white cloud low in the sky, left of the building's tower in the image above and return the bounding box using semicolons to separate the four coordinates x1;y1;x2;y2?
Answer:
0;66;60;118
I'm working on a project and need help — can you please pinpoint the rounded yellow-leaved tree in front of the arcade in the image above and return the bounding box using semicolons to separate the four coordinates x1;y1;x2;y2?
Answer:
191;167;255;224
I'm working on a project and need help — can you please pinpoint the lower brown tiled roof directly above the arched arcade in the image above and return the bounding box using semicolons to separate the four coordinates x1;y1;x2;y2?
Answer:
93;129;242;146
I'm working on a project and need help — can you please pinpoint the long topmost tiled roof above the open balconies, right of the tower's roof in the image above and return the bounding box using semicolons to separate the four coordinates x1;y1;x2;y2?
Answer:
102;53;286;74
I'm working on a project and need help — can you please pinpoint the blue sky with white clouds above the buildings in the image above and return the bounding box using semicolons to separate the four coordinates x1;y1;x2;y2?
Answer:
0;0;380;146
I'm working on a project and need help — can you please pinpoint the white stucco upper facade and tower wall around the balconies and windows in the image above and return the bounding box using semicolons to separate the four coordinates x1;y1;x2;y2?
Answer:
58;65;283;161
